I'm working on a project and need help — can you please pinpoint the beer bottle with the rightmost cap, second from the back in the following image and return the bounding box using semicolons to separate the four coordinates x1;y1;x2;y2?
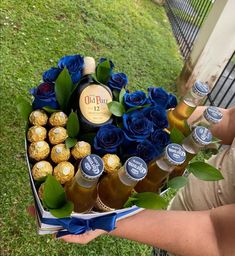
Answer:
191;106;223;129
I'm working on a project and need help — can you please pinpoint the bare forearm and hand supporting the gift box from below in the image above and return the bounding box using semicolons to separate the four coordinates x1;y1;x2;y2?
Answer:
59;204;235;256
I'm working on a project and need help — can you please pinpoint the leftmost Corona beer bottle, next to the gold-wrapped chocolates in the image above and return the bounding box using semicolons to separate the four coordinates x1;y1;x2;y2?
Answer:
65;154;104;213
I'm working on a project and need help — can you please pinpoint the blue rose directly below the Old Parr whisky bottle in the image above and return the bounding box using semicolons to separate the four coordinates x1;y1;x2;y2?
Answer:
94;124;124;155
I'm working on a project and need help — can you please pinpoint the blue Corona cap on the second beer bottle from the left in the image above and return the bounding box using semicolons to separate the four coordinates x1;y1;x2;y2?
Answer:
124;156;148;181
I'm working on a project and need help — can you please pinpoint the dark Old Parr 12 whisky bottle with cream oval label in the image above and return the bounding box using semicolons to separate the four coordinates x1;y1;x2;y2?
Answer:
75;57;113;131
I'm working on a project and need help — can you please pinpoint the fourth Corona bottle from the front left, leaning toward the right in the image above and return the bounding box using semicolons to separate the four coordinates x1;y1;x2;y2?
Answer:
170;126;212;179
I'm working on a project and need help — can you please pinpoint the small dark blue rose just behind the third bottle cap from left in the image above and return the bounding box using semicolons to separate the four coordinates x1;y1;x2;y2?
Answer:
150;129;170;152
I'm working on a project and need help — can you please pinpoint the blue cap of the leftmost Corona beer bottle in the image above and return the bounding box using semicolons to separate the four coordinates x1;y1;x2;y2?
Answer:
80;154;104;180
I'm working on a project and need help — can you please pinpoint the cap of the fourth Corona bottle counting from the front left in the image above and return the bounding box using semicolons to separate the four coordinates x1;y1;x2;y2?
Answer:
192;126;212;146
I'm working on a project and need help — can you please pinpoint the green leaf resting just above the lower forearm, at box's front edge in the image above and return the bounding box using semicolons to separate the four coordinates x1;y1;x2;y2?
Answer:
125;192;167;209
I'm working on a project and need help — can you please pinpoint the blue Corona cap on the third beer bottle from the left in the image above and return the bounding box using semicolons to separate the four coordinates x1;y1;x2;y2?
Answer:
165;143;186;165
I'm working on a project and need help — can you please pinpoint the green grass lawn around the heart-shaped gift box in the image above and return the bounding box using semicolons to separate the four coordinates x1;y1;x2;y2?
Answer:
0;0;182;256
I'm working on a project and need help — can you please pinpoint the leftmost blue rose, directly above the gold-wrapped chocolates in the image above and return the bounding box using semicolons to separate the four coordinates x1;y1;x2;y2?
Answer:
30;83;59;109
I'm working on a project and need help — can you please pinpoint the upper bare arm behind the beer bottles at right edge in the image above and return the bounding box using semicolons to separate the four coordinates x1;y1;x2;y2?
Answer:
187;106;235;145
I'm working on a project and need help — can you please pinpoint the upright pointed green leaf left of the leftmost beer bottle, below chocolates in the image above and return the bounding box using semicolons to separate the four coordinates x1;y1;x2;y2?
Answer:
43;175;66;209
